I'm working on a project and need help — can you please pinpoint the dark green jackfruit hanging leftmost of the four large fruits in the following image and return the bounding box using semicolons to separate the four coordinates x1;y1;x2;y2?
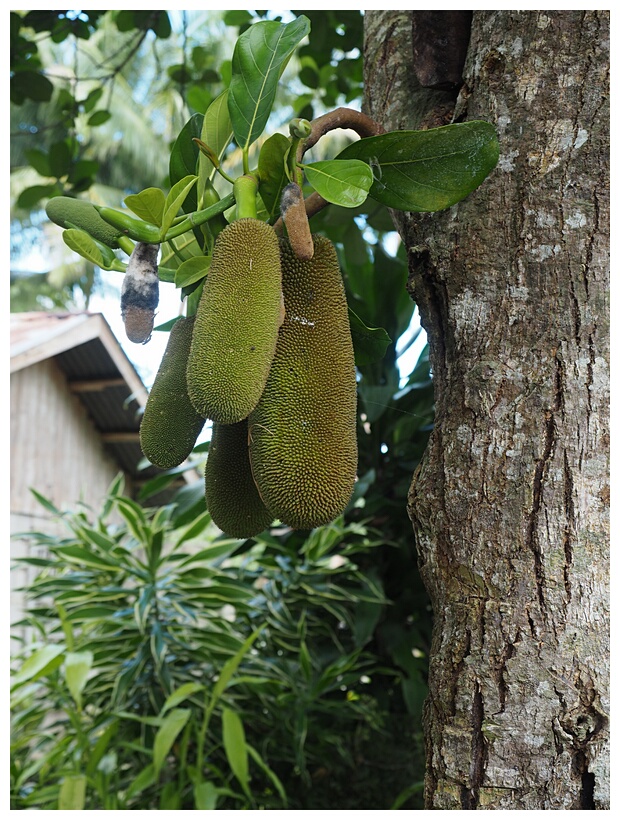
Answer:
140;317;205;470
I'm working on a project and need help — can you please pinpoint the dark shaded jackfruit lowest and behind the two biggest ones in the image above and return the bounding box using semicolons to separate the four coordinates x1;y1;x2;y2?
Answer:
205;419;273;538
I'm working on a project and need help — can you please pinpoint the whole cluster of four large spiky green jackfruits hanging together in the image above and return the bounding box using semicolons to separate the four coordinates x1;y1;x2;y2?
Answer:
135;219;357;538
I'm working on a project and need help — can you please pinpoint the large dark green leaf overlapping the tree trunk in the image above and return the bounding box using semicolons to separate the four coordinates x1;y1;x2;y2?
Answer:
338;120;499;212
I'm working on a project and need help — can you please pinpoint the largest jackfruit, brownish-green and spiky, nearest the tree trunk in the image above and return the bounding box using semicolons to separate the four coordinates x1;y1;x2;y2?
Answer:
248;235;357;529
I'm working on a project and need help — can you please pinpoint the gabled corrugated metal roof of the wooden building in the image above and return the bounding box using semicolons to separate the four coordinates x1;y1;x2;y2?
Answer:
11;312;196;496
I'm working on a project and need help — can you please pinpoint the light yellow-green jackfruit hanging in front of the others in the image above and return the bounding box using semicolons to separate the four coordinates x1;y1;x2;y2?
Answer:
187;218;282;424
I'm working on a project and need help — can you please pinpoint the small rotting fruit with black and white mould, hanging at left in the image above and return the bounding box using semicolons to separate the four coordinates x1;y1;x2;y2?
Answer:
121;242;159;344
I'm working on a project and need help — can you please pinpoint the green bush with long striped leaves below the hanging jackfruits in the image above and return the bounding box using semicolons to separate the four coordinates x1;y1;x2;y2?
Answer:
11;479;422;810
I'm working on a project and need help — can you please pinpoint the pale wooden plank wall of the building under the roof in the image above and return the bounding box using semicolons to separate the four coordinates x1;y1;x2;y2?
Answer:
10;359;126;637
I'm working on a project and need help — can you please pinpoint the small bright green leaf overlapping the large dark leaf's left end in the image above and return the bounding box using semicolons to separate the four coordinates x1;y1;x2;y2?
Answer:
302;159;373;208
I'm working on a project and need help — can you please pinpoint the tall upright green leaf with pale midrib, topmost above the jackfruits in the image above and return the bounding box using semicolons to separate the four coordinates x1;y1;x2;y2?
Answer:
228;15;310;150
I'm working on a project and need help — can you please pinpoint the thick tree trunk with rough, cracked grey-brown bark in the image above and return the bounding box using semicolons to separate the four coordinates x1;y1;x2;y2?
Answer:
364;11;609;809
